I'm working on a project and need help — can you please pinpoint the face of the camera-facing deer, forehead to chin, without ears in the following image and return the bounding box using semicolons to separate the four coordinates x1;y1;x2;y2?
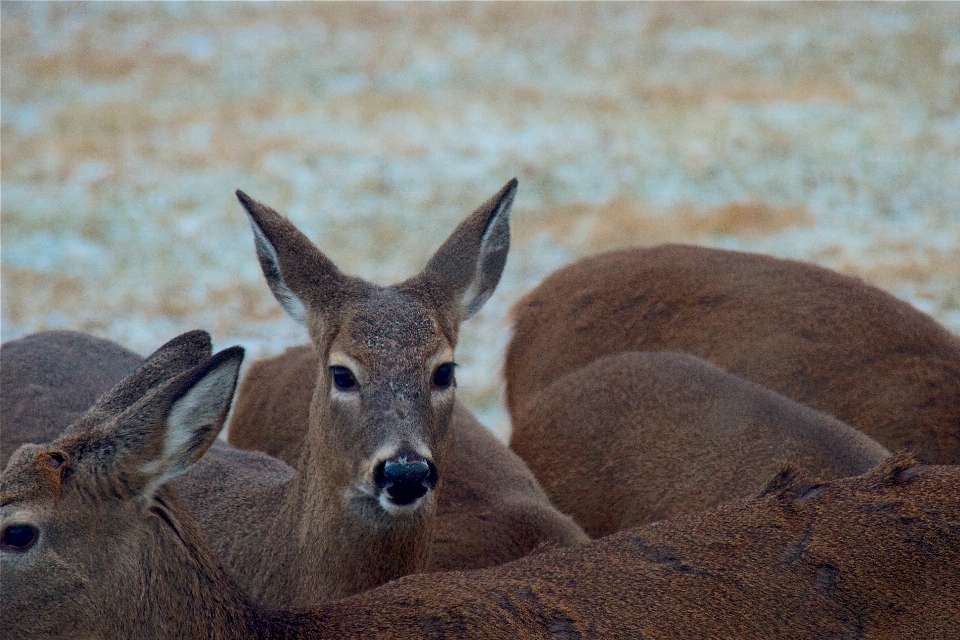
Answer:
311;287;455;520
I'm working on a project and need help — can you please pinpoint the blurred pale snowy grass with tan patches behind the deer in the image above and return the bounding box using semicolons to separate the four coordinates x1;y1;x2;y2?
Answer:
0;0;960;436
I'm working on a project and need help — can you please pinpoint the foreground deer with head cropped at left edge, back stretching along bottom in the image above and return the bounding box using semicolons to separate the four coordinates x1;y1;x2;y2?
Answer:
0;347;960;640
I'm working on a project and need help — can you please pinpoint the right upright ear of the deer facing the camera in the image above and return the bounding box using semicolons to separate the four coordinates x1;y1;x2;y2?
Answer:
411;178;517;321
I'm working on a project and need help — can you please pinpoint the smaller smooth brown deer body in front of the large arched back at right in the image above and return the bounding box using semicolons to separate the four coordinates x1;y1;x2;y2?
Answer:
511;351;889;537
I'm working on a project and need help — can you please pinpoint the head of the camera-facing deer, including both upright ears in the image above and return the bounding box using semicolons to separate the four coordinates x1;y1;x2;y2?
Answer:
237;180;516;526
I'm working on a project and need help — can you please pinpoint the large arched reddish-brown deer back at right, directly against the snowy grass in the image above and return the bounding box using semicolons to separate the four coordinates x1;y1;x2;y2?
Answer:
505;245;960;464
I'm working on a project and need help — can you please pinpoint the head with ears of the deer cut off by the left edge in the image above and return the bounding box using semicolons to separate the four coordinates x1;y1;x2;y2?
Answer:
0;340;243;638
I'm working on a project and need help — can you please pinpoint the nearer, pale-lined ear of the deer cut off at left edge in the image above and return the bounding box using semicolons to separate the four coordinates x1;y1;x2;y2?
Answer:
129;347;243;497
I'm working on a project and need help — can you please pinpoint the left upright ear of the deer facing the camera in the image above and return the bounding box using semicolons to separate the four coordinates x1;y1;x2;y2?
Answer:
237;190;344;326
